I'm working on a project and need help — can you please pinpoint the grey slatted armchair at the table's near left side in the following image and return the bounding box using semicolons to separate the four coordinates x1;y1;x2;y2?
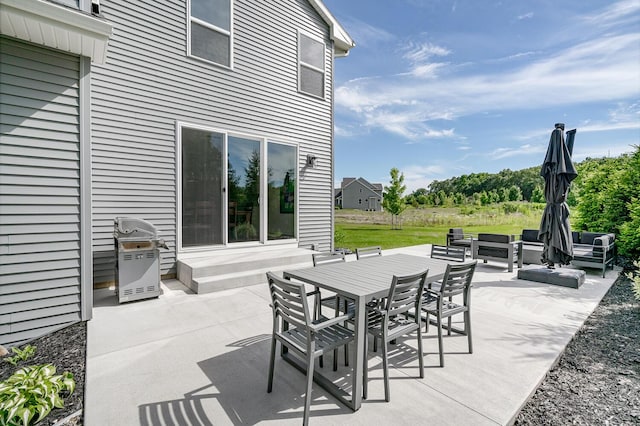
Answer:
267;272;354;425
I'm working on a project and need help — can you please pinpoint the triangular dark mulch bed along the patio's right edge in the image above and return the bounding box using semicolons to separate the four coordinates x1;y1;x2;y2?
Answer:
515;275;640;425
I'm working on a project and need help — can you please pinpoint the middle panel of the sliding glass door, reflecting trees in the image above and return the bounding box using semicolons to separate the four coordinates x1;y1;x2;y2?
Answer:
227;136;260;243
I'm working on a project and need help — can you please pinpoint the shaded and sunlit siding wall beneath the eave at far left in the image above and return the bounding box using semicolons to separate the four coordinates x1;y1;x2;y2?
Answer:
0;37;82;345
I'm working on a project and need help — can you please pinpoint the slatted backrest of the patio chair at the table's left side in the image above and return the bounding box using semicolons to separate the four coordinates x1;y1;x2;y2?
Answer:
267;272;311;329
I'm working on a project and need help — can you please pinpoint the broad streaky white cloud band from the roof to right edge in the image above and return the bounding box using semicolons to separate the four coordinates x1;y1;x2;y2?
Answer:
336;32;640;138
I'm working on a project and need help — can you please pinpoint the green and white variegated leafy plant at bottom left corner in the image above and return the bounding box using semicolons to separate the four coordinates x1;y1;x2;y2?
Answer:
0;364;76;426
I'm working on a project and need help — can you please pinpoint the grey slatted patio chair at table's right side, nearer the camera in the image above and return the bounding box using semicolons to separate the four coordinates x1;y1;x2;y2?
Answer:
363;270;428;402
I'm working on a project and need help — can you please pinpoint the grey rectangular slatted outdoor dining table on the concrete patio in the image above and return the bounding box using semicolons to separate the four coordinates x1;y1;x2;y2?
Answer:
282;254;449;411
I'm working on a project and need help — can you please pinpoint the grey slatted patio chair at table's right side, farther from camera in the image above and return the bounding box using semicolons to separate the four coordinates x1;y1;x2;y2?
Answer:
416;260;478;367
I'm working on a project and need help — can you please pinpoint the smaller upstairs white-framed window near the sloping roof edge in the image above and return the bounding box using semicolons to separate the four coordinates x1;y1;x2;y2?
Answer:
298;33;325;98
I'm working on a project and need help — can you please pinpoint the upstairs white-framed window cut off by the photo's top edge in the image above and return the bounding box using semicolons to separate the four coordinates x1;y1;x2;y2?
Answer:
189;0;233;67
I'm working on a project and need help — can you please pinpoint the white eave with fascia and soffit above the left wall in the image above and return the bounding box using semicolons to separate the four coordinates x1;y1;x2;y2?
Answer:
0;0;113;64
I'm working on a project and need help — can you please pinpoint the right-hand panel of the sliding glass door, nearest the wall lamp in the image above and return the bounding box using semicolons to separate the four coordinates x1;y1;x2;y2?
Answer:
267;142;297;240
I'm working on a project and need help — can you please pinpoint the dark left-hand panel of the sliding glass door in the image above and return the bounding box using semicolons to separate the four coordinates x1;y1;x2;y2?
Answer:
182;127;224;247
